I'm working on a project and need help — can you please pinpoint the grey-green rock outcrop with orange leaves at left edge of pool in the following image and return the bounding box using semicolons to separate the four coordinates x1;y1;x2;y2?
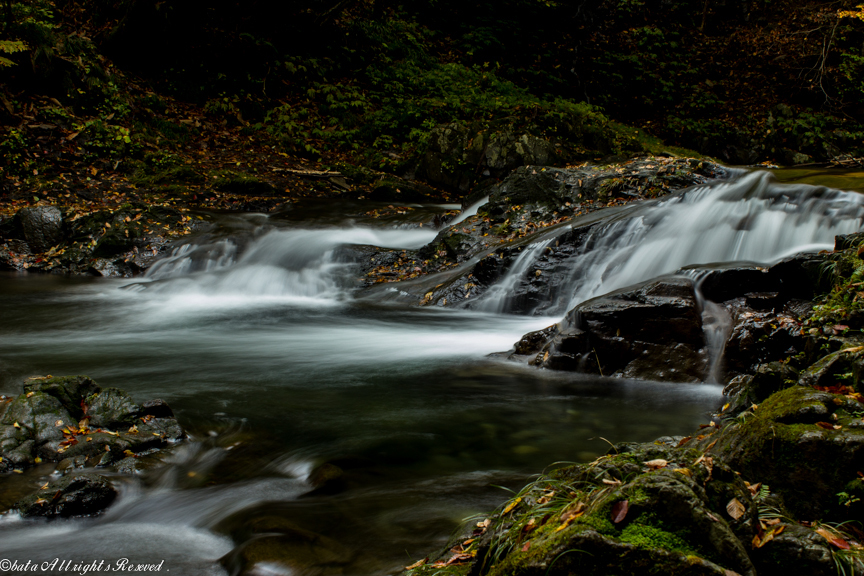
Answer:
0;376;185;471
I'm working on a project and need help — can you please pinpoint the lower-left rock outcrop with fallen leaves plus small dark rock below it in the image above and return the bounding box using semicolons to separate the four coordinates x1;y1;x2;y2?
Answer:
0;376;186;517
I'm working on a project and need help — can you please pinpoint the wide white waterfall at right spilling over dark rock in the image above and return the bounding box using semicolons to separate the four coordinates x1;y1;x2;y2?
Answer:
482;172;864;315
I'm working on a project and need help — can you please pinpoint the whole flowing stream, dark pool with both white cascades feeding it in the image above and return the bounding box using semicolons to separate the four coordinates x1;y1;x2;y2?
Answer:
0;170;861;576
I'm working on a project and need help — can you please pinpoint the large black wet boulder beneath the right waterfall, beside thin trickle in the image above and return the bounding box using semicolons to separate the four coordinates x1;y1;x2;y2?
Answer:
528;278;707;382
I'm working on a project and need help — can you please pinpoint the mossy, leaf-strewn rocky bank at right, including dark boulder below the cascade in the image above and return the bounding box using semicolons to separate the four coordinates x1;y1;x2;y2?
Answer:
406;235;864;576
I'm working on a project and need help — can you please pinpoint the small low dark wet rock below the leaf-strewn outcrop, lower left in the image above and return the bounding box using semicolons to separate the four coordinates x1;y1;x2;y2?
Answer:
15;474;117;518
